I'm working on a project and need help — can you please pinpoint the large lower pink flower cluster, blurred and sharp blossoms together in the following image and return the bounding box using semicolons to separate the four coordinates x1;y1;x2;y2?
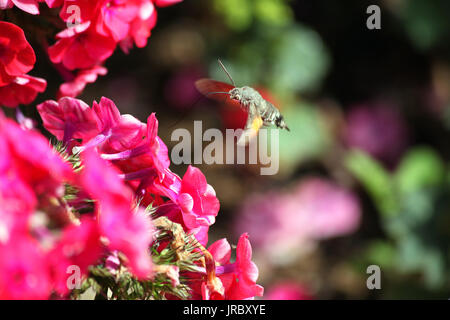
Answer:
0;97;263;299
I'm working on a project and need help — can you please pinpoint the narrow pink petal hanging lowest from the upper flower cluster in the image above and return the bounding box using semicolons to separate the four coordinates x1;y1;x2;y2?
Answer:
57;66;108;97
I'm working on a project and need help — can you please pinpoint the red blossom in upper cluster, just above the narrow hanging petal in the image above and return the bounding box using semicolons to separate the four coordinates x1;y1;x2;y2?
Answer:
48;21;116;70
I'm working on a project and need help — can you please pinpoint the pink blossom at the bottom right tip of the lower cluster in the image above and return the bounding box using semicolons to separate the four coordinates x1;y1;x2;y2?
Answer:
202;233;264;300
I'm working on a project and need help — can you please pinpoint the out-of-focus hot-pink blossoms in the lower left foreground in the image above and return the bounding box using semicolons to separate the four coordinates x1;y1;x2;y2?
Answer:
0;110;152;299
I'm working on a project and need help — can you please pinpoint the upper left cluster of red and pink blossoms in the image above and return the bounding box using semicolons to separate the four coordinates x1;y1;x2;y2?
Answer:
0;0;181;107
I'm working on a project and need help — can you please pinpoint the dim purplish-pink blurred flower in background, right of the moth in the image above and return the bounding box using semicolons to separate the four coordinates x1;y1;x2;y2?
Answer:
344;101;408;166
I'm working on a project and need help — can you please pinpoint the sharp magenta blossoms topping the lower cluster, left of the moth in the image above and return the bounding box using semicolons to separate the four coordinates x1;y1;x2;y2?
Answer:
38;97;170;180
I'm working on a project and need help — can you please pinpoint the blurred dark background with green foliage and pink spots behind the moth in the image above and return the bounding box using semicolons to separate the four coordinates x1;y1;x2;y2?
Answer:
30;0;450;299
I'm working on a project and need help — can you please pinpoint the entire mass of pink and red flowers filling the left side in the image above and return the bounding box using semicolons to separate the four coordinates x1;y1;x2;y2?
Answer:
0;0;263;299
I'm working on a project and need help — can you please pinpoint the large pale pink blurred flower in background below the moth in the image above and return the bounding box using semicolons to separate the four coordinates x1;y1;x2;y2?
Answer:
235;178;361;264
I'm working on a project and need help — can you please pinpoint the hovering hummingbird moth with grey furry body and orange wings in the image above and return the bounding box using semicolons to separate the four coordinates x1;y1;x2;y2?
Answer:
195;59;290;145
